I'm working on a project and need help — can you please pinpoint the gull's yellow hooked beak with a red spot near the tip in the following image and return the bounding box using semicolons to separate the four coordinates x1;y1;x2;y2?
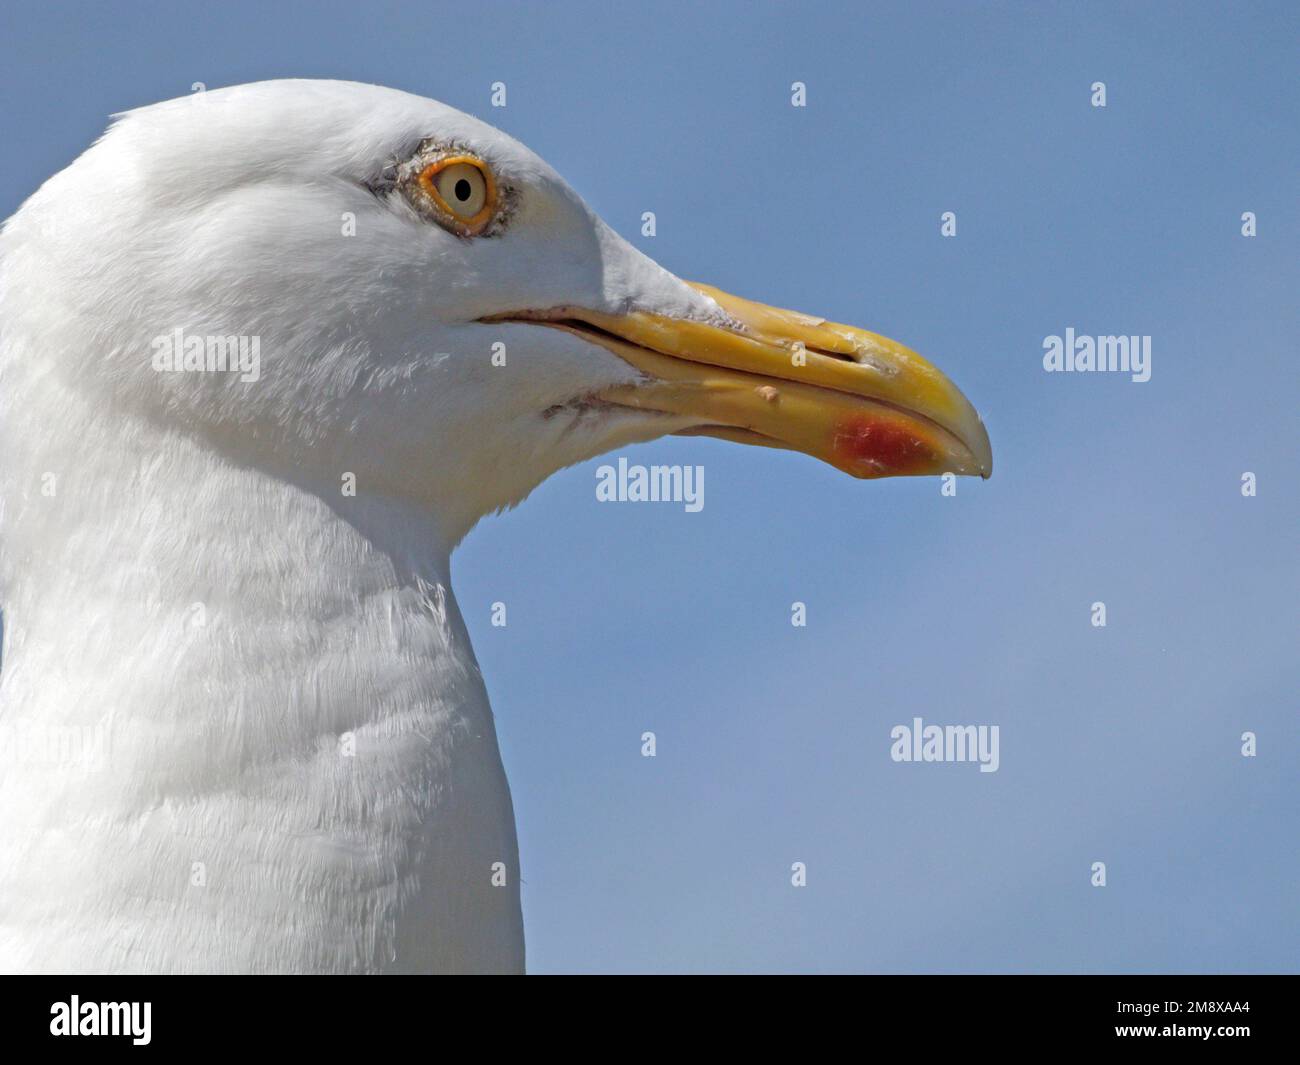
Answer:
491;285;993;477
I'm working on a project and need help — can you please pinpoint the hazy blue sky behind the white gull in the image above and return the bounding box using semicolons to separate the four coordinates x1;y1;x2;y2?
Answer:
0;0;1300;971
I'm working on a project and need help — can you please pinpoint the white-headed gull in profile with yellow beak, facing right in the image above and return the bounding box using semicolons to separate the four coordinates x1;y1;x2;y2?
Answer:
0;79;992;973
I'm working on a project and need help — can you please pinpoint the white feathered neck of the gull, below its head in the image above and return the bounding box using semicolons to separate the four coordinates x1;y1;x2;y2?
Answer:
0;395;523;970
